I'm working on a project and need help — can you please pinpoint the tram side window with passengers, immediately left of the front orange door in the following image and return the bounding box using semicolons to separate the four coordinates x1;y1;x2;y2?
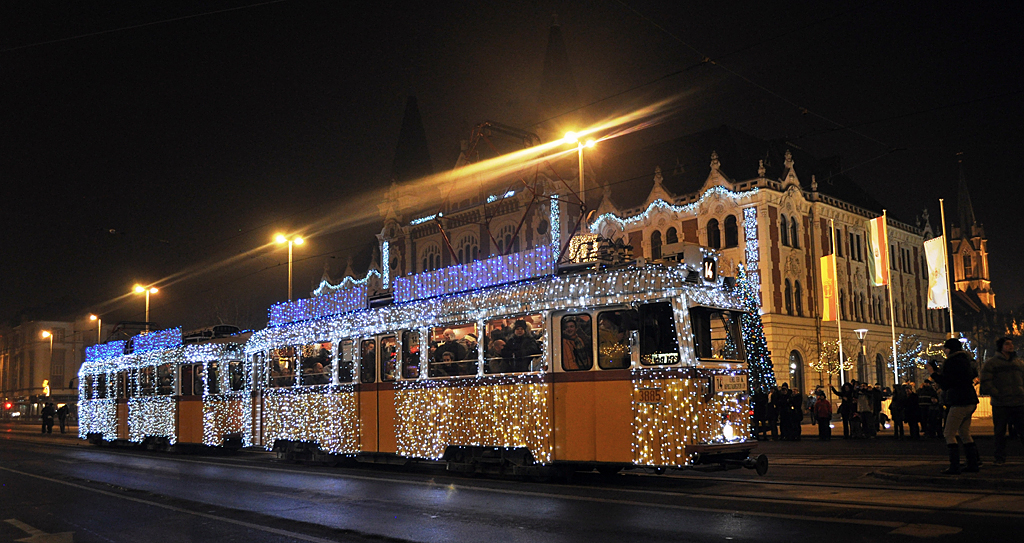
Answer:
483;314;544;374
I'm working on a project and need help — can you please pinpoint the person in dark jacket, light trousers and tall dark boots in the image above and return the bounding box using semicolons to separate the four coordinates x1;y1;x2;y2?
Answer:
928;338;981;475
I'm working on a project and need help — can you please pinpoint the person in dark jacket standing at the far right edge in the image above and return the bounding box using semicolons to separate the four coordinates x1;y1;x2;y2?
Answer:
981;337;1024;464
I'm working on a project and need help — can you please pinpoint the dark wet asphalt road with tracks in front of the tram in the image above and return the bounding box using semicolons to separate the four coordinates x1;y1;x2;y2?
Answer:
0;428;1024;543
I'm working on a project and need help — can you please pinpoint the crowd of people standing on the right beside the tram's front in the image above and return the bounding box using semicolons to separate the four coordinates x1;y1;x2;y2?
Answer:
752;337;1024;474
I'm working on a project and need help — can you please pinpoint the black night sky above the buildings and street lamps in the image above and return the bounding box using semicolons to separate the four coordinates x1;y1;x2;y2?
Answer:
0;0;1024;328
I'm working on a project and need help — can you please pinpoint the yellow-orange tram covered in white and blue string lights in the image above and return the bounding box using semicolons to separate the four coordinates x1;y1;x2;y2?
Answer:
80;240;767;475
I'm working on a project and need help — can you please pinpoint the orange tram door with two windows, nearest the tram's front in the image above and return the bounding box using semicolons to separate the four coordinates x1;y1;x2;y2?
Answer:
551;309;633;463
